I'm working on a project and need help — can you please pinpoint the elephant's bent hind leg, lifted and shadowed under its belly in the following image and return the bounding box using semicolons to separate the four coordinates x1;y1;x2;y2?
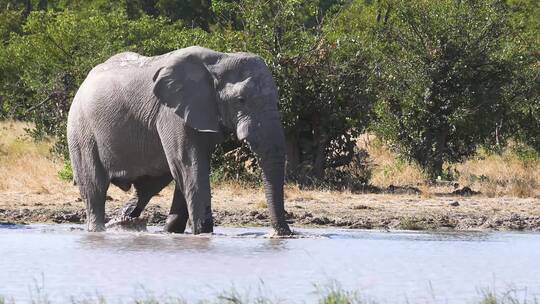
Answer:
122;174;172;218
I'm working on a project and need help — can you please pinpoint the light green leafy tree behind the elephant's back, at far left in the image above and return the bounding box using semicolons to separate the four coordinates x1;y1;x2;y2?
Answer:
0;10;212;157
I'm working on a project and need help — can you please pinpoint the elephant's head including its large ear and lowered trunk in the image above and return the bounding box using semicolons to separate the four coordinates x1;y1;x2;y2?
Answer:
154;49;291;235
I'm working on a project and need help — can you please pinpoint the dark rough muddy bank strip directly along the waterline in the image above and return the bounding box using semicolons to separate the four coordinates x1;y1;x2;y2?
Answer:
0;206;540;231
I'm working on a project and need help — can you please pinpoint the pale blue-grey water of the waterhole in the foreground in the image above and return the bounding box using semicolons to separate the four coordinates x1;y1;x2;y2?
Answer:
0;225;540;303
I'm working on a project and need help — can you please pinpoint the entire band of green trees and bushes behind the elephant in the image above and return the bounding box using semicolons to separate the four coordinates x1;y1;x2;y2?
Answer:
0;0;540;184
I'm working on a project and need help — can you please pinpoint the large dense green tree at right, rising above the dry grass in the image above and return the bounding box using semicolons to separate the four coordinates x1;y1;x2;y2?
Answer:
373;0;514;178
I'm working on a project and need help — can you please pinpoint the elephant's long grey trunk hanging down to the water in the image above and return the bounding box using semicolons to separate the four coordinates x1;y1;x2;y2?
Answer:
248;116;292;235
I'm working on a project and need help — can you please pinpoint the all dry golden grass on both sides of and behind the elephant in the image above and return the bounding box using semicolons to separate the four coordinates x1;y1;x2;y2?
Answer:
0;121;540;200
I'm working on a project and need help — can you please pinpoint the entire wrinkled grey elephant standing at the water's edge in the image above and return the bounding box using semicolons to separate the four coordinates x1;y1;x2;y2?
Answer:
67;46;291;235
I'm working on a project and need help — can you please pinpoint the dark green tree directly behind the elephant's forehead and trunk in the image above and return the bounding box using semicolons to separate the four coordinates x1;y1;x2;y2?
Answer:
211;0;373;184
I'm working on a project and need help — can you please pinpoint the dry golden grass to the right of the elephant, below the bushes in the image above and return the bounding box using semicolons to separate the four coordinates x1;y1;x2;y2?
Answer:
358;134;540;198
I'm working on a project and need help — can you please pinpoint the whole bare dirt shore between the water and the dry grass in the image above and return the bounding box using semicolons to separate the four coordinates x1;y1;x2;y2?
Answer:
0;184;540;231
